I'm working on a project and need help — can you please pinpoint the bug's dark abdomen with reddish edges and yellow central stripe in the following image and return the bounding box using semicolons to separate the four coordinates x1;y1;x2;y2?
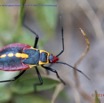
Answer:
0;43;30;71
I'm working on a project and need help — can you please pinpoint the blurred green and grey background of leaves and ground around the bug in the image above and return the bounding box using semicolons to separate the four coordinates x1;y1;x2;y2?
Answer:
0;0;104;103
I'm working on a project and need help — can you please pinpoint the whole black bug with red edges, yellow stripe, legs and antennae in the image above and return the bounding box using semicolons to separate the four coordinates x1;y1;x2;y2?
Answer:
0;15;89;87
